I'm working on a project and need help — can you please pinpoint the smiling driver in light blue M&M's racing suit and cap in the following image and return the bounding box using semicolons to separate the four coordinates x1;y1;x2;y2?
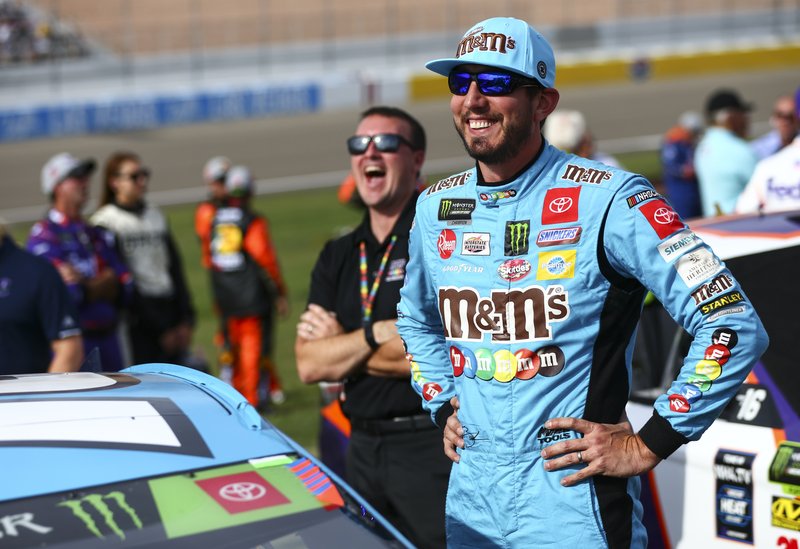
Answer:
398;18;767;548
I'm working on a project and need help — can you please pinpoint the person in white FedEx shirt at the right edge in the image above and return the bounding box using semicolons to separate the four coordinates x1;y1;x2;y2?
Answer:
736;88;800;213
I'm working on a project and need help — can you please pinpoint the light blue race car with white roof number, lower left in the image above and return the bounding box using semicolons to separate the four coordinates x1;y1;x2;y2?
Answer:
0;364;412;549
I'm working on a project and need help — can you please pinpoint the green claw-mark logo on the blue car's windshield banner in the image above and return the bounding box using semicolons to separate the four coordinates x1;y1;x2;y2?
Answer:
58;491;142;540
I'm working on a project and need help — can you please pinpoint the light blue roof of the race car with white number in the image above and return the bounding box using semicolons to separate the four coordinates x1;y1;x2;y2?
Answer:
0;364;302;501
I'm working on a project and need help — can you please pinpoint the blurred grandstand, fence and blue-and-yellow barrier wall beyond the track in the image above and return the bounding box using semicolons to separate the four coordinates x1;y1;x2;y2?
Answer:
0;0;800;142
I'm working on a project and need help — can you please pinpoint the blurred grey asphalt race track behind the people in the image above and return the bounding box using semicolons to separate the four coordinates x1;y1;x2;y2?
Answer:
0;69;800;223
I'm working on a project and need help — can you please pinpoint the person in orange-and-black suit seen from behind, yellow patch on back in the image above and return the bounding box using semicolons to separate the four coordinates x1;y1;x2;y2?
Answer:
208;166;289;408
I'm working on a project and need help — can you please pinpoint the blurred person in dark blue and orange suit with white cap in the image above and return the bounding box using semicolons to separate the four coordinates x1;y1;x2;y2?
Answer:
661;111;703;219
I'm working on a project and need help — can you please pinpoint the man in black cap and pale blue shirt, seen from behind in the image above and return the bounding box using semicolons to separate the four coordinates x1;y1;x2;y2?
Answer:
694;89;758;217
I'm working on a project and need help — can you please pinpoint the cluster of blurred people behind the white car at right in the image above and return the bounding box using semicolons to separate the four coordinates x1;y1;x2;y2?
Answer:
661;87;800;218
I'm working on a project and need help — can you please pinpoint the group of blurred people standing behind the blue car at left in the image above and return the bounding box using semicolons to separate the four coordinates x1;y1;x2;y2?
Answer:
0;151;288;410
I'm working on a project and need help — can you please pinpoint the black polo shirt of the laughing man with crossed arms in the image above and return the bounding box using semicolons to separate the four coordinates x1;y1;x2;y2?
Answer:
308;193;424;419
